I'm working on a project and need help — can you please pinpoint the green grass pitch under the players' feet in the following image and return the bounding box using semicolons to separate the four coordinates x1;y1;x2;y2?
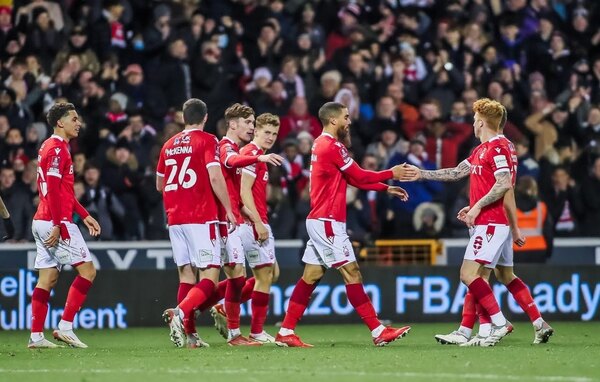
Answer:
0;322;600;382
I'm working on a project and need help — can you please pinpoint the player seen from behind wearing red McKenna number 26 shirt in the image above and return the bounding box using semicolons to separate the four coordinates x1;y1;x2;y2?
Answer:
156;98;236;348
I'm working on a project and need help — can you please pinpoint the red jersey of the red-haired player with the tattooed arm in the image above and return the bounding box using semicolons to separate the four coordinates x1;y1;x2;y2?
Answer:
467;137;511;225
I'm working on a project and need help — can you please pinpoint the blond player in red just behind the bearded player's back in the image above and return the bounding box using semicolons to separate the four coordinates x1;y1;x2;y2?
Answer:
240;113;279;343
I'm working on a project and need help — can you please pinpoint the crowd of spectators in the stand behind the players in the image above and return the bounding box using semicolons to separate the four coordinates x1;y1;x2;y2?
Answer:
0;0;600;242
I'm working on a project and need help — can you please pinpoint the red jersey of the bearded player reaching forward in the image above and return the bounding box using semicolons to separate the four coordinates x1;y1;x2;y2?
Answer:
308;133;354;222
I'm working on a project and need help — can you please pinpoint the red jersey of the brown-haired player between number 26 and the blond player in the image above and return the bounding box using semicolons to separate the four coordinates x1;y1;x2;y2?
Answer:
219;137;244;224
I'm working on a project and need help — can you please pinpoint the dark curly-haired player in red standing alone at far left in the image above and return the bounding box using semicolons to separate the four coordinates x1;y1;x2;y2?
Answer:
28;103;100;348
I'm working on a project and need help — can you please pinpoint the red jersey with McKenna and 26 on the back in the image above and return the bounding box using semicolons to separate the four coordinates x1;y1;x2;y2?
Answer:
156;129;220;225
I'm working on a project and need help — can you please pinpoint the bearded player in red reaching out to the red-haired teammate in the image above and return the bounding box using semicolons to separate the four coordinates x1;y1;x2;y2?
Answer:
275;102;414;347
